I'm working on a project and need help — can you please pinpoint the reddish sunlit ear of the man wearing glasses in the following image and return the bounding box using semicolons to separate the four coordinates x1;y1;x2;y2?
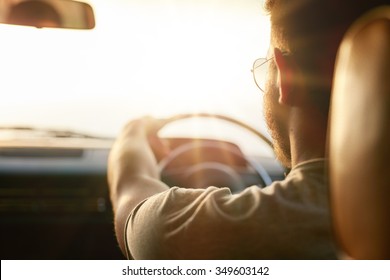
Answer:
274;48;298;106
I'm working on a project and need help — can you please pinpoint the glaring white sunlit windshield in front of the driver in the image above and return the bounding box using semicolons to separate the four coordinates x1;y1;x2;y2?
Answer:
0;0;269;153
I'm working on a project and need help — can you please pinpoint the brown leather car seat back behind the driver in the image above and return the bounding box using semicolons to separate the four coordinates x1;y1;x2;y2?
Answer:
328;6;390;259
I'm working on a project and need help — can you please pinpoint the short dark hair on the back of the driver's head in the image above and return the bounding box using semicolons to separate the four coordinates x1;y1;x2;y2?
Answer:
264;0;390;112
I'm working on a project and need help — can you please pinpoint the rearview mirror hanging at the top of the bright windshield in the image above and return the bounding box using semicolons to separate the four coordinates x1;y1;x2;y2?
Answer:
0;0;95;29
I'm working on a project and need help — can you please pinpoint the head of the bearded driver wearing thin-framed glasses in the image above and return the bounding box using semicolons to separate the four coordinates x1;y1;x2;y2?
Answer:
264;0;390;166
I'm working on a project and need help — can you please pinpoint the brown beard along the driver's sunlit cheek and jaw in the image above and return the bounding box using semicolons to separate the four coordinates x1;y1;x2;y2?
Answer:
263;83;291;168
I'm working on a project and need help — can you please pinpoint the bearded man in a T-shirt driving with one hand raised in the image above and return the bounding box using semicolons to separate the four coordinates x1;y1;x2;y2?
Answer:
108;0;388;259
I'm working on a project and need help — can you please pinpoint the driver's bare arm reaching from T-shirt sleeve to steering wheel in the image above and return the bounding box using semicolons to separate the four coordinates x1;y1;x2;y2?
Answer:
108;119;169;253
